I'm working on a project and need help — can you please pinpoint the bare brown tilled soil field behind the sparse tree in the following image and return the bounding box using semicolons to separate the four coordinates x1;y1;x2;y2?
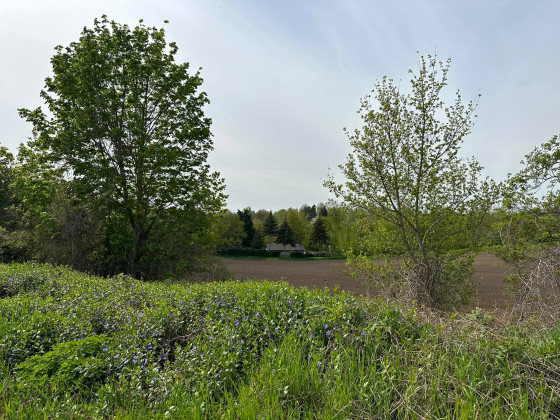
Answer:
224;253;506;310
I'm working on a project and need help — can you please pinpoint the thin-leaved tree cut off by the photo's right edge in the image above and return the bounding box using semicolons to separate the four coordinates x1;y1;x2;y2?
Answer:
498;135;560;317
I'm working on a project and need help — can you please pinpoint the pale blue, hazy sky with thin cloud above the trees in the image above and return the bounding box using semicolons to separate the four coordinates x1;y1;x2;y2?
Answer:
0;0;560;211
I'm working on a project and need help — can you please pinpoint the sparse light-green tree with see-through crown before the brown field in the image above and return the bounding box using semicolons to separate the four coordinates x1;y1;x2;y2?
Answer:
325;56;496;308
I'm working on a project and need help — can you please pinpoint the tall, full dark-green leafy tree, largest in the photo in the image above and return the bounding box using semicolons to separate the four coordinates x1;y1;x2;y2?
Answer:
20;16;225;277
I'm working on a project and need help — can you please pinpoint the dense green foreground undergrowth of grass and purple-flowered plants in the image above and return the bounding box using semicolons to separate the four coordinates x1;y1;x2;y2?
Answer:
0;264;560;419
